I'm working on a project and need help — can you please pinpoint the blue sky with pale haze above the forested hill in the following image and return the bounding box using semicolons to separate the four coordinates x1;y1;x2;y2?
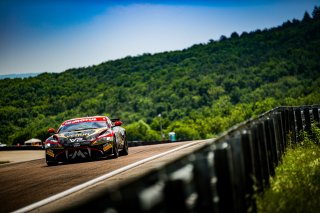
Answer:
0;0;320;75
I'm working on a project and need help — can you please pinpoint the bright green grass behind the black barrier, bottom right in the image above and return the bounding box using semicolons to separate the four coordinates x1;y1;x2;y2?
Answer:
257;125;320;213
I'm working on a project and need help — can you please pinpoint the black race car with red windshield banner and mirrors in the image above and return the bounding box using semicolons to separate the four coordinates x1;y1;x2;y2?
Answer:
44;116;129;166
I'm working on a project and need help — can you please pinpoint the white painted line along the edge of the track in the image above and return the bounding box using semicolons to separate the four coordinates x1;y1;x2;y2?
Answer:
13;141;208;213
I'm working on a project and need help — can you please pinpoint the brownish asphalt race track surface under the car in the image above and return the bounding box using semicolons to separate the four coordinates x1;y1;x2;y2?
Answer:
0;141;205;212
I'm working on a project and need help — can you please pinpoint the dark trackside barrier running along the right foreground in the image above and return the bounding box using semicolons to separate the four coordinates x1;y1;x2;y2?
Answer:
58;105;320;213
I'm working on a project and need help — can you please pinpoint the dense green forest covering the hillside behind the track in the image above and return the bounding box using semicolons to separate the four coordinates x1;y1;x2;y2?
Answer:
0;7;320;144
